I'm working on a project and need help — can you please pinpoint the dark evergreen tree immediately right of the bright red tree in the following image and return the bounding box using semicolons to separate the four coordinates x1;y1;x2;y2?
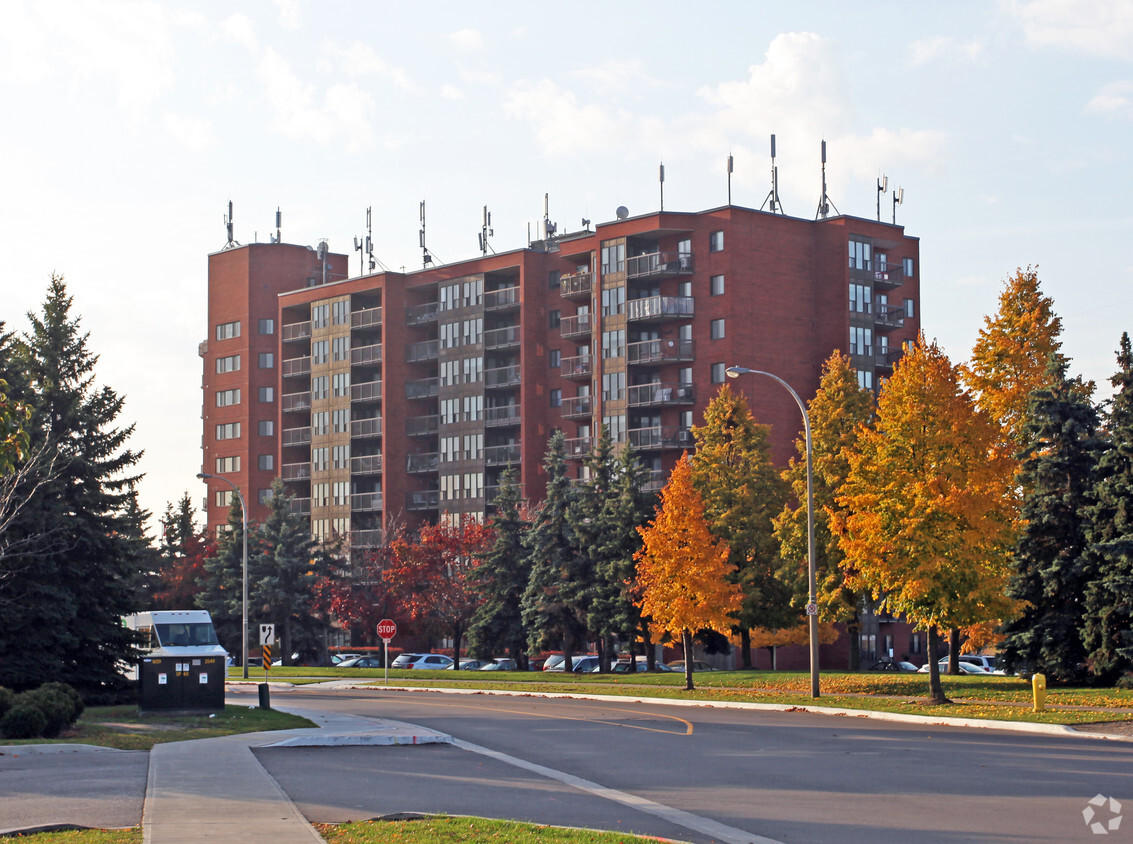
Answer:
468;469;531;667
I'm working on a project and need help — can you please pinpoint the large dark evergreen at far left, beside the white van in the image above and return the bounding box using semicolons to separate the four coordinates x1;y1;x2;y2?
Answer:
0;276;142;692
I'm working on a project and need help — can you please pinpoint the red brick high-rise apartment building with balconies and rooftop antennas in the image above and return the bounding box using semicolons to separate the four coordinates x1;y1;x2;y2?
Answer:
201;205;920;655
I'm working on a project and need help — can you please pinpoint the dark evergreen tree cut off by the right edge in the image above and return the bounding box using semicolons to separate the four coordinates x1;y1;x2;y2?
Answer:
1082;333;1133;681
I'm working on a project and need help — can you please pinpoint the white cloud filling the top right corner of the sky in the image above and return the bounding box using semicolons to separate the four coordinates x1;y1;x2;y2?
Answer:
1005;0;1133;61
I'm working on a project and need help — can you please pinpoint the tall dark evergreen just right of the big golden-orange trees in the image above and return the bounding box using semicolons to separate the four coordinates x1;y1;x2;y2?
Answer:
1000;356;1102;682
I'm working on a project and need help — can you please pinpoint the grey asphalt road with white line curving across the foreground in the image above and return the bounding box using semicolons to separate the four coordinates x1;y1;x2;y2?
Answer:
248;688;1133;844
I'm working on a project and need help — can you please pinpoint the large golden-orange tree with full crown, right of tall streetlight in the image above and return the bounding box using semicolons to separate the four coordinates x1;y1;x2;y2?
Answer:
830;336;1015;702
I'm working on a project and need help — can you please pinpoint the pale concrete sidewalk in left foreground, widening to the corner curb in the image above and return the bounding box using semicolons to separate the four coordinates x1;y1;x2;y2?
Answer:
142;707;452;844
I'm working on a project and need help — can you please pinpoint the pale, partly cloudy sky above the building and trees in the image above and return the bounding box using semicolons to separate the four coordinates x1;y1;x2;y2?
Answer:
0;0;1133;530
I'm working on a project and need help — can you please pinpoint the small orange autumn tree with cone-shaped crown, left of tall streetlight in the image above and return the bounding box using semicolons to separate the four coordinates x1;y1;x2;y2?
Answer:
634;453;743;691
